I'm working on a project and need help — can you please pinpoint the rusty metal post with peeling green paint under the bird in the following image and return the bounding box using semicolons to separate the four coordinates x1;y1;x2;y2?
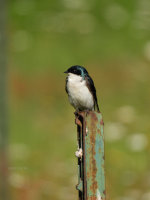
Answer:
76;111;106;200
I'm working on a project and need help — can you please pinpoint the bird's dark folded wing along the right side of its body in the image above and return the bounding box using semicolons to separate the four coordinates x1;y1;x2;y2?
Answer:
85;75;100;112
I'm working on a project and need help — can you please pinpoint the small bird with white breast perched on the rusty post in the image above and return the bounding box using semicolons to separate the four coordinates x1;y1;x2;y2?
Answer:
64;65;100;112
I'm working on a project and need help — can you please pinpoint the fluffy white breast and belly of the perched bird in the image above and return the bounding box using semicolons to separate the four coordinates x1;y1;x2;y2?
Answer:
67;73;94;110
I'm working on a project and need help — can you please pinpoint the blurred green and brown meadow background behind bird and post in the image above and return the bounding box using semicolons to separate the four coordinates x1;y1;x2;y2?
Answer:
8;0;150;200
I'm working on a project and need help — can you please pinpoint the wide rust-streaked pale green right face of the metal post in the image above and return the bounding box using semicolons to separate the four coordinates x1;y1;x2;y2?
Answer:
85;112;105;199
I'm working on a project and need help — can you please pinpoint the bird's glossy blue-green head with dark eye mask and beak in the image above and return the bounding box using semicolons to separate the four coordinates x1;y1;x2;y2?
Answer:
64;65;88;80
